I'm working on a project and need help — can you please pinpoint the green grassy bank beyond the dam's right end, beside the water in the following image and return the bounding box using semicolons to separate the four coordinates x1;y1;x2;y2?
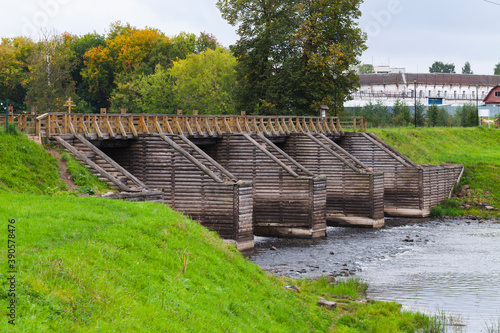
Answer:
370;127;500;216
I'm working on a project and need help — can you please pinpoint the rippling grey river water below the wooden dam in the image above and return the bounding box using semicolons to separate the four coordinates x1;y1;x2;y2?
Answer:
249;219;500;333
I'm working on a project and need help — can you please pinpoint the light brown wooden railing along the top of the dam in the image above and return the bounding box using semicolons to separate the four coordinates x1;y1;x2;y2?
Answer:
0;113;366;138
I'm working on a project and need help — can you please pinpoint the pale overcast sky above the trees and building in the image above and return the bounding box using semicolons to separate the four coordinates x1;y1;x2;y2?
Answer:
0;0;500;74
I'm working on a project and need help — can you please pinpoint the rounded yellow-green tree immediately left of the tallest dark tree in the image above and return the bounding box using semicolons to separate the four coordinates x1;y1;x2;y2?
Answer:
169;47;236;114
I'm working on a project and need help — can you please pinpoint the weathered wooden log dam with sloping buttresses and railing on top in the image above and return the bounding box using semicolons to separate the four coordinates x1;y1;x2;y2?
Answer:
0;113;463;250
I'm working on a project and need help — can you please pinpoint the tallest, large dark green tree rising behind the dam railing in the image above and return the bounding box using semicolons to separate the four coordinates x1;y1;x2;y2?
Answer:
217;0;366;114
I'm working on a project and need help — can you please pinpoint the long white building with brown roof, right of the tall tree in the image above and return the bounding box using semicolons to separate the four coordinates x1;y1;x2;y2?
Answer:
344;73;500;107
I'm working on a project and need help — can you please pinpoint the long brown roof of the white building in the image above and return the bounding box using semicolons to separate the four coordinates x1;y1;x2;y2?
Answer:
359;73;500;87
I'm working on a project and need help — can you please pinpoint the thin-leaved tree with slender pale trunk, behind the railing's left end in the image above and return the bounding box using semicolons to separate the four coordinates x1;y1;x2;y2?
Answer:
24;31;76;112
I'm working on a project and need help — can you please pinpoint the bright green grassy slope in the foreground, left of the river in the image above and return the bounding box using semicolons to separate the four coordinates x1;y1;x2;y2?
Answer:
0;133;442;332
